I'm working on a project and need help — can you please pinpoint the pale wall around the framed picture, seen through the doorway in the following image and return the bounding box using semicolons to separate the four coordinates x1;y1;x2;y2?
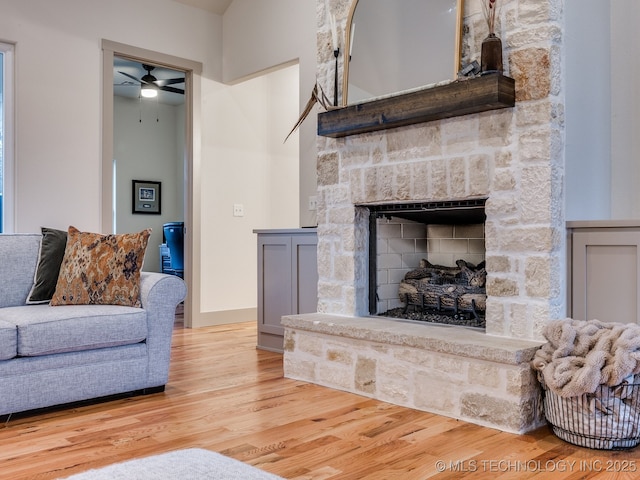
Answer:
113;97;185;272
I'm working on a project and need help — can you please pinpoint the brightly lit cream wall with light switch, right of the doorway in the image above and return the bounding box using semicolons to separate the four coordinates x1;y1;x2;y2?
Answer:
194;65;299;318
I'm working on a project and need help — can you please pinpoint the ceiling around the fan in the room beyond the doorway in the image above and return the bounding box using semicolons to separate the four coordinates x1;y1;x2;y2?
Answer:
113;57;185;105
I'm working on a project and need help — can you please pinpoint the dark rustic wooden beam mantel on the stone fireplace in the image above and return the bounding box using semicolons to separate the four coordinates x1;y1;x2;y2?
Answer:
318;72;516;138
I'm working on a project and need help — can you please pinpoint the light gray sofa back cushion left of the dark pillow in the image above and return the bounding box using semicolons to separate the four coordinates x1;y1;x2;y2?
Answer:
0;234;42;308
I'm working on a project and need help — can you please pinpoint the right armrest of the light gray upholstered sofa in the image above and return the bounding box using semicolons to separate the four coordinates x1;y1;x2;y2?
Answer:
140;272;187;388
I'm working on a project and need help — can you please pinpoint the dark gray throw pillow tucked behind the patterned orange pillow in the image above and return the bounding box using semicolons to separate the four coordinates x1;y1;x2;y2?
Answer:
27;227;67;305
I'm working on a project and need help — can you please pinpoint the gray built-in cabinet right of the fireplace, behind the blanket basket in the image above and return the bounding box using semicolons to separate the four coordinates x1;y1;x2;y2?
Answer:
567;220;640;324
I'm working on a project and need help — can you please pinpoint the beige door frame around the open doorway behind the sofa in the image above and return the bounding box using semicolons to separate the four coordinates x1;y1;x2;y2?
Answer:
100;39;202;327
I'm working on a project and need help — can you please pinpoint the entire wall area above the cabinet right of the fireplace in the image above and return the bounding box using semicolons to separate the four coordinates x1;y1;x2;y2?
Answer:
564;0;640;220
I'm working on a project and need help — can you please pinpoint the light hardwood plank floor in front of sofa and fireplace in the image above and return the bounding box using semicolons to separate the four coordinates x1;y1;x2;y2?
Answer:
0;323;640;480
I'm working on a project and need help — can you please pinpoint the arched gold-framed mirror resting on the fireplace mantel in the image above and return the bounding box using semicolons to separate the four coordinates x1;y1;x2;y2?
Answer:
342;0;464;106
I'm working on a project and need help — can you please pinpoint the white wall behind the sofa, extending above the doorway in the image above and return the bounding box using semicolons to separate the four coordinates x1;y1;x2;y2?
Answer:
0;0;222;232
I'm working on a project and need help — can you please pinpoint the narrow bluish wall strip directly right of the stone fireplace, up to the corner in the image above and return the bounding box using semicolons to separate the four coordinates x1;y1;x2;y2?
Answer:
563;0;615;220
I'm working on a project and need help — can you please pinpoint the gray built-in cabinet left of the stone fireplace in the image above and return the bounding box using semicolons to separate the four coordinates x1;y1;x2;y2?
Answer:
254;228;318;352
